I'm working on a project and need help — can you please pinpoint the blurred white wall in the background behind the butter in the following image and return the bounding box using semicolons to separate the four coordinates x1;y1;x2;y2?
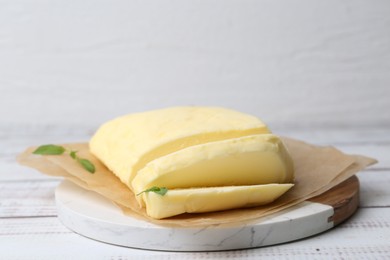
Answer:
0;0;390;133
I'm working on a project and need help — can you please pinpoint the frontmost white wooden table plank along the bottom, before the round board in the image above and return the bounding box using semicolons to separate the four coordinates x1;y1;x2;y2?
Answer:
0;208;390;259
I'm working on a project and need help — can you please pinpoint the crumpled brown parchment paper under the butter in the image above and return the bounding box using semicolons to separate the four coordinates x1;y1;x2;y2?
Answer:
18;138;376;227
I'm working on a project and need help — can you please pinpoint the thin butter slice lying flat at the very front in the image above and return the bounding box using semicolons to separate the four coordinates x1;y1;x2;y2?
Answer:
140;184;293;219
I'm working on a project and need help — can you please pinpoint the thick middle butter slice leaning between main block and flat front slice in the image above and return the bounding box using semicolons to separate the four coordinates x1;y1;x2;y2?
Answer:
132;134;294;205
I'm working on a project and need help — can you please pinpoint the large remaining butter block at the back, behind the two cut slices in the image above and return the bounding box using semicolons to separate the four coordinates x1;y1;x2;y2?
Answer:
89;107;269;189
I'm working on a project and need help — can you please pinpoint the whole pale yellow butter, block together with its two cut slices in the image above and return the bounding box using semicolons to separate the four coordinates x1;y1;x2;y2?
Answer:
89;107;294;218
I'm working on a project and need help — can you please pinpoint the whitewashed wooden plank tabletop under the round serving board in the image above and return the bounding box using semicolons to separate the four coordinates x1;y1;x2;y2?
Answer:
0;127;390;259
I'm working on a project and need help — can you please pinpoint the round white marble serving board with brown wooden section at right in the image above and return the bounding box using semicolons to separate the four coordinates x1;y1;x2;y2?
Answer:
55;176;359;251
